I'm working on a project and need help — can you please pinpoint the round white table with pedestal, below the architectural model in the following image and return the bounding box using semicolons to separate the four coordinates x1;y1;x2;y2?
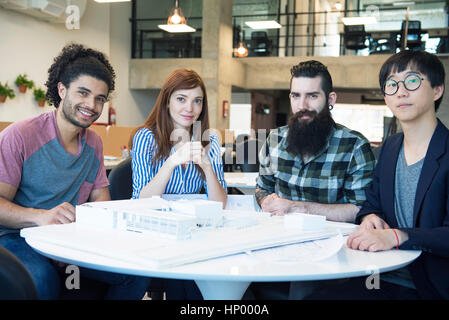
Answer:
22;224;421;299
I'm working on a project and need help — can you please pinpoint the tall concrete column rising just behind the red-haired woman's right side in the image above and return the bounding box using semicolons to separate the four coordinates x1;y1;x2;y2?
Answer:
201;0;233;129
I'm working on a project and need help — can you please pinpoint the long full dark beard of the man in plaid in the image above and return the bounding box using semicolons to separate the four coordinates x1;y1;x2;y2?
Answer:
287;105;335;157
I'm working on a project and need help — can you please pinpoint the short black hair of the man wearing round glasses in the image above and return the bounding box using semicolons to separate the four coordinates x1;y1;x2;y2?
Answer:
379;50;445;112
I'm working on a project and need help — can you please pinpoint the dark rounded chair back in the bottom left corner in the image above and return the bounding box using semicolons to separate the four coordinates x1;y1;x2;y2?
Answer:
0;246;38;300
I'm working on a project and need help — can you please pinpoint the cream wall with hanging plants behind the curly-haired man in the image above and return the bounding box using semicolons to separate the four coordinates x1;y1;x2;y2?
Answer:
0;0;154;126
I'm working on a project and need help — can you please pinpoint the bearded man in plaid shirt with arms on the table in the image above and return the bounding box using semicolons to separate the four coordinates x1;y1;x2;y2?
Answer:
255;60;375;222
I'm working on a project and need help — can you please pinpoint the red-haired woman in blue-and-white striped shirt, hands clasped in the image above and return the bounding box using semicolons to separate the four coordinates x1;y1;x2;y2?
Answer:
130;68;227;206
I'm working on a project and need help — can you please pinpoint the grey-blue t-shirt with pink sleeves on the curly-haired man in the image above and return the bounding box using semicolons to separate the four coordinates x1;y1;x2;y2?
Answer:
0;111;109;236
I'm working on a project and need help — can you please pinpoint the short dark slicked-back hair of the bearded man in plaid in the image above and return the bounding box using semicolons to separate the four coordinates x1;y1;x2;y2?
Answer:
290;60;334;98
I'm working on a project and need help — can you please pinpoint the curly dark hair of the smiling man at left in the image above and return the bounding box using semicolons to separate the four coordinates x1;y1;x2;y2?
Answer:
45;43;115;108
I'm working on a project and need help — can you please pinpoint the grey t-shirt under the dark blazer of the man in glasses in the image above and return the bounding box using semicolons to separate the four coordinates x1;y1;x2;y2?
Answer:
381;145;424;289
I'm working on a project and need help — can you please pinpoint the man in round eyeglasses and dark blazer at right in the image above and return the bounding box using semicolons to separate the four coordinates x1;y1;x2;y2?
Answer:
313;51;449;300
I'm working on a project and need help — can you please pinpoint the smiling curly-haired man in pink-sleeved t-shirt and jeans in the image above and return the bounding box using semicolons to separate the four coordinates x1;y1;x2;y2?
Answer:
0;44;148;299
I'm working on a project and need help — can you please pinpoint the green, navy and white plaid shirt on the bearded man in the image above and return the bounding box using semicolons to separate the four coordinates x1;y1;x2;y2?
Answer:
257;124;375;208
